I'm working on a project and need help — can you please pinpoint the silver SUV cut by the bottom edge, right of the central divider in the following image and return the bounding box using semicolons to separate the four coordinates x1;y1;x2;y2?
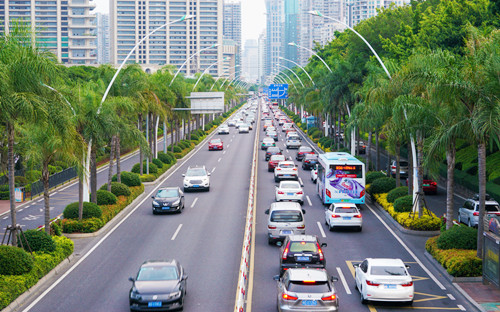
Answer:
274;268;339;312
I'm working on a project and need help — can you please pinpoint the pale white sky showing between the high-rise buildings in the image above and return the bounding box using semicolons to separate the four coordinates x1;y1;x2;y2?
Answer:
94;0;266;45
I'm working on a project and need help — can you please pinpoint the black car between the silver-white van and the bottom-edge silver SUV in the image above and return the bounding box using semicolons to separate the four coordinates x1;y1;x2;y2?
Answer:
280;235;326;275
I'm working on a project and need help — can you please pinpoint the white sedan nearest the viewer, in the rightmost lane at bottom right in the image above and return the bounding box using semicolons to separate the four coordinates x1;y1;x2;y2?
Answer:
354;258;414;304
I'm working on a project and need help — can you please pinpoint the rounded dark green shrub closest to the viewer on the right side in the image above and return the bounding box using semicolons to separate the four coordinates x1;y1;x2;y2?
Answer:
437;226;477;250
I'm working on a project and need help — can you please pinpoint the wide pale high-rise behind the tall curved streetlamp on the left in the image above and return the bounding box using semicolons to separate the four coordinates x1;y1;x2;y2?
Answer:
110;0;223;76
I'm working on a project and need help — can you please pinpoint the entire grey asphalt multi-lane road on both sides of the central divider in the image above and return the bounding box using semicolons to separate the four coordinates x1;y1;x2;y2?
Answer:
14;98;476;312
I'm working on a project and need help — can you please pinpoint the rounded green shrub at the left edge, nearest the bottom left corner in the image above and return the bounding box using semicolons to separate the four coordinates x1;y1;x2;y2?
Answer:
0;245;33;275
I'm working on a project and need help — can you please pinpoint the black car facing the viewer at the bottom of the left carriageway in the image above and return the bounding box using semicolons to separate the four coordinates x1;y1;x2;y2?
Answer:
129;260;187;311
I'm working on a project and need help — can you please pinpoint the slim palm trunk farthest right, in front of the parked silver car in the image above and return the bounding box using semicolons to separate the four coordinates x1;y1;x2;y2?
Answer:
477;142;486;258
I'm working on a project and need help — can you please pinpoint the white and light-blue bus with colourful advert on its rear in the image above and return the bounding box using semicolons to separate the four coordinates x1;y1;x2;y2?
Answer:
317;153;365;205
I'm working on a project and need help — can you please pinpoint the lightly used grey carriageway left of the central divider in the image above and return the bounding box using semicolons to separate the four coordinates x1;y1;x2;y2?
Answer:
19;108;253;311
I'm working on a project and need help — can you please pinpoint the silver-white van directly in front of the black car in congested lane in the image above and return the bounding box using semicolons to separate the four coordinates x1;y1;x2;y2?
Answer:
266;202;306;246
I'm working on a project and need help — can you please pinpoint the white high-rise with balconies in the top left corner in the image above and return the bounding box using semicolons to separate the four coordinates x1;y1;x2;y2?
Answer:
0;0;97;65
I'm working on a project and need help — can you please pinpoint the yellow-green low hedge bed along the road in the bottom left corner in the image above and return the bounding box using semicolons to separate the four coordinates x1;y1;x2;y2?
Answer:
0;236;73;310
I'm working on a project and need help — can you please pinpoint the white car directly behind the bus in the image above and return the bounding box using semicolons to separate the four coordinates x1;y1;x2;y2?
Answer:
325;203;363;231
